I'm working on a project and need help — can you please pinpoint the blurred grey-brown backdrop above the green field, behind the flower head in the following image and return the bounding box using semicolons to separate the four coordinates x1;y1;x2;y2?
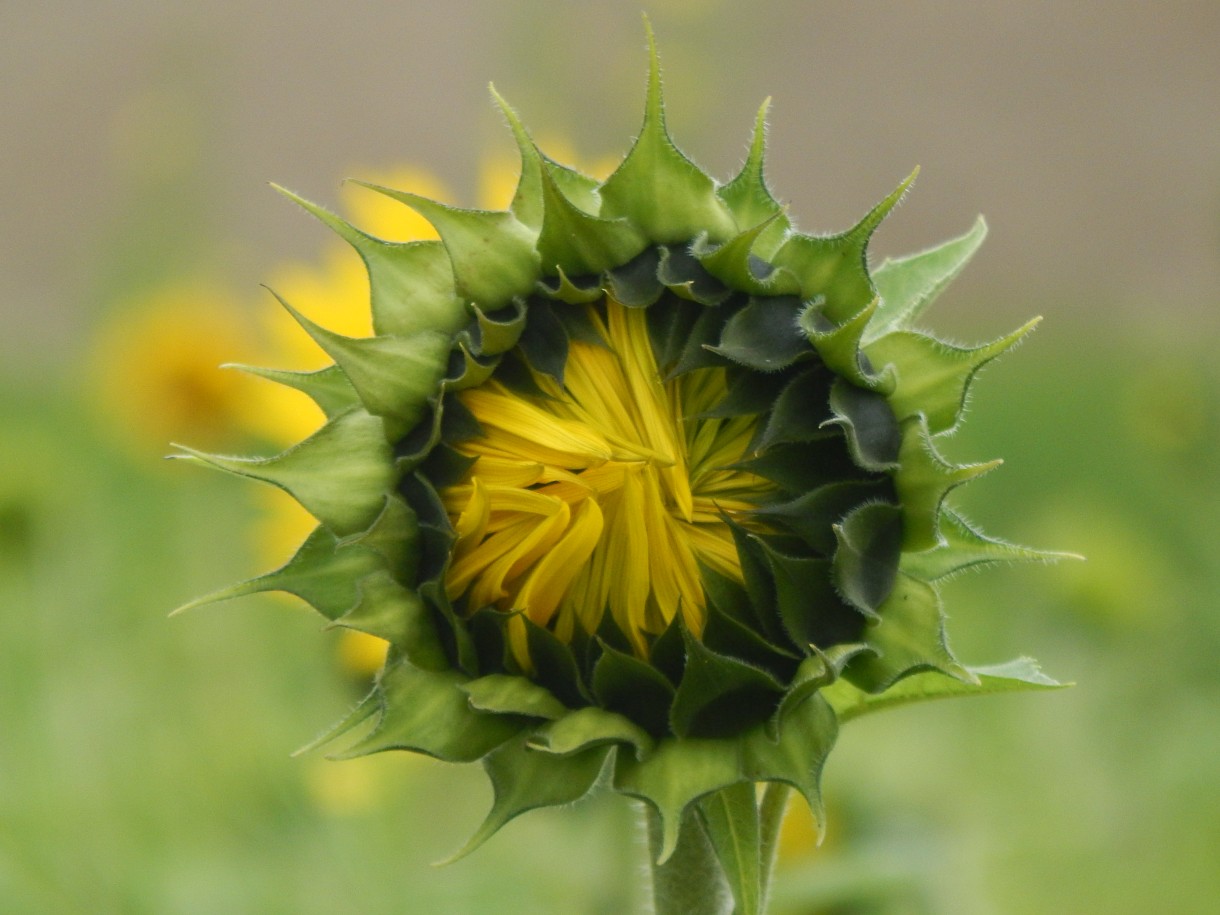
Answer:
0;0;1220;366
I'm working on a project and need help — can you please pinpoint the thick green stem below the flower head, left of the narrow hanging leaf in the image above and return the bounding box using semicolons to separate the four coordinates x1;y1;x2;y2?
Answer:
644;804;733;915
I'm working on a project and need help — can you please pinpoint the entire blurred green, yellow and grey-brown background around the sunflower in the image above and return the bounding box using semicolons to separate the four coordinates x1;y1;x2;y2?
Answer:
7;0;1220;915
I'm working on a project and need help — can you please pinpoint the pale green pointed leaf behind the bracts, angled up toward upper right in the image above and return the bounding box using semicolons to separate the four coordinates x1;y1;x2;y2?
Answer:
869;216;987;339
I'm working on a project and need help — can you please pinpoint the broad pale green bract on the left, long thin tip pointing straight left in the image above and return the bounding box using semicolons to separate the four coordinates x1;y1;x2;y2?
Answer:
174;409;395;536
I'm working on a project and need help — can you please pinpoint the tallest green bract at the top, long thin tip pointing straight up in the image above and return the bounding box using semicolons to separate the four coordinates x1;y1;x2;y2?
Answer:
600;28;737;244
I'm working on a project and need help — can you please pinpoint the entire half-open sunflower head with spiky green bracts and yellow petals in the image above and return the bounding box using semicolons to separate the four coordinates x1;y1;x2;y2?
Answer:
174;28;1055;911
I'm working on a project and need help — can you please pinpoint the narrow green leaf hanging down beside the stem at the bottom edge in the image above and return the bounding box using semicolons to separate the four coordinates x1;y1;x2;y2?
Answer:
699;782;763;915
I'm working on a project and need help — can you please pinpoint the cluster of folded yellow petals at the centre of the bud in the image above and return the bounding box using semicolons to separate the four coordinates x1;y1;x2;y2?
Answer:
442;299;772;670
